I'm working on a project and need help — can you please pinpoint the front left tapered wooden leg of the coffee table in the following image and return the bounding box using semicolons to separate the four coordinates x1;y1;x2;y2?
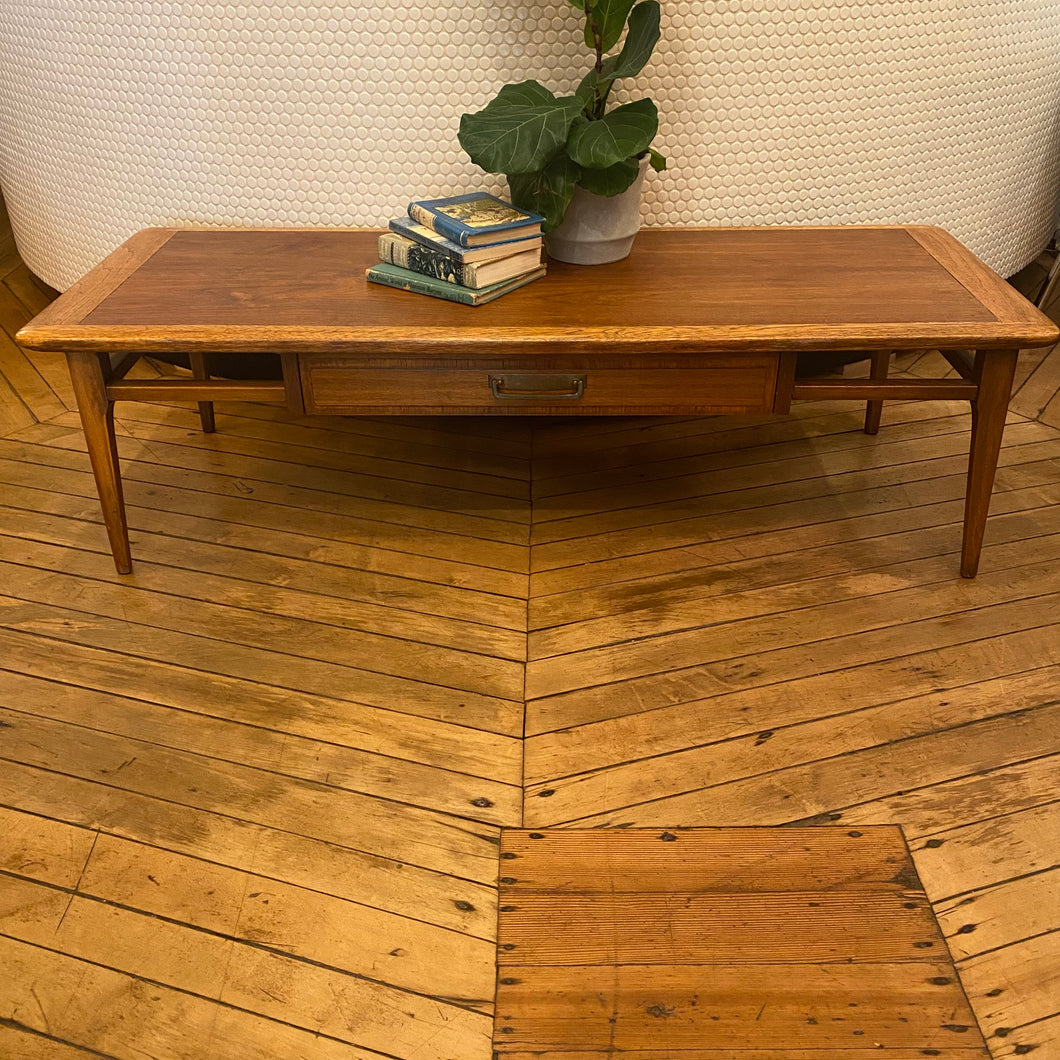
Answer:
67;352;133;575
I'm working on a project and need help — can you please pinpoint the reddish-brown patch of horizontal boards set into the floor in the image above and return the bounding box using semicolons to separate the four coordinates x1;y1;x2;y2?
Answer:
493;826;988;1060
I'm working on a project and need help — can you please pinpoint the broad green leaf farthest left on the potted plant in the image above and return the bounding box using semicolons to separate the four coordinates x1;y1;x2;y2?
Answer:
457;81;583;173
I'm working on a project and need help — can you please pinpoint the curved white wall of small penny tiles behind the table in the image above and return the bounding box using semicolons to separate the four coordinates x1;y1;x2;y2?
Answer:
0;0;1060;288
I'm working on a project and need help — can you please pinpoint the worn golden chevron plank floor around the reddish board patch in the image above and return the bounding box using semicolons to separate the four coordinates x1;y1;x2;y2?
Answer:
0;213;1060;1060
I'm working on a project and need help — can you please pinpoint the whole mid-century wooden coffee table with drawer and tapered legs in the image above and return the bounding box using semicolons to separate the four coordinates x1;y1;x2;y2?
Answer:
18;226;1060;578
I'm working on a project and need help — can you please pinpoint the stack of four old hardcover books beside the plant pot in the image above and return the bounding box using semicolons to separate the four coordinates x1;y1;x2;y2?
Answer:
366;192;545;305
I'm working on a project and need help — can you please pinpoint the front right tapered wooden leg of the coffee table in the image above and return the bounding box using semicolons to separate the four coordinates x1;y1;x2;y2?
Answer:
960;350;1020;578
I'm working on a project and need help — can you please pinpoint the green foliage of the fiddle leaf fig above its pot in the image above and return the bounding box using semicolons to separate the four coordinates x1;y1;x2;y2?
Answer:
458;0;666;232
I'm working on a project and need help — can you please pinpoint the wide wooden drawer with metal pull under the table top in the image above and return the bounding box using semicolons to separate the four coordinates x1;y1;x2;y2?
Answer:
300;354;777;416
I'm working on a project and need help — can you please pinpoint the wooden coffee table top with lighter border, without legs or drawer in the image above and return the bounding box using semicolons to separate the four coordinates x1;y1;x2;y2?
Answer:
20;227;1058;354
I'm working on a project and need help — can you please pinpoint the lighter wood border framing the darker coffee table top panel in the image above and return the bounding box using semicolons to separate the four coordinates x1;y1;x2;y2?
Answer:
19;226;1060;355
